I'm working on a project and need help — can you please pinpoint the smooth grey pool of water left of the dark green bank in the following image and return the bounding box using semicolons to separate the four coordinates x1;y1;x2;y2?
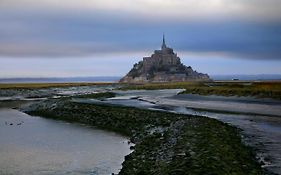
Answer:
0;108;130;175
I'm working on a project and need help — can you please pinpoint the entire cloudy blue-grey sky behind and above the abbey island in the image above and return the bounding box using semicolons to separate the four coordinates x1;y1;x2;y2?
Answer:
0;0;281;78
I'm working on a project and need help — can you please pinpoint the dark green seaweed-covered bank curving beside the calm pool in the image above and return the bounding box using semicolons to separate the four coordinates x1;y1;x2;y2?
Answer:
24;93;263;175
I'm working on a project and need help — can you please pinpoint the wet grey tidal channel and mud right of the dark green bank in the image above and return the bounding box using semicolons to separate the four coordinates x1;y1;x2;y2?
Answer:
74;89;281;174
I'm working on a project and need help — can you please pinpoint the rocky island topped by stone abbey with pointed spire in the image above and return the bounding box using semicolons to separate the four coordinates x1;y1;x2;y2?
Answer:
120;35;210;83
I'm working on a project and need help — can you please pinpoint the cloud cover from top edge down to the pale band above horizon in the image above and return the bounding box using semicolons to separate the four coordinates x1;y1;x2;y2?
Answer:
0;0;281;60
